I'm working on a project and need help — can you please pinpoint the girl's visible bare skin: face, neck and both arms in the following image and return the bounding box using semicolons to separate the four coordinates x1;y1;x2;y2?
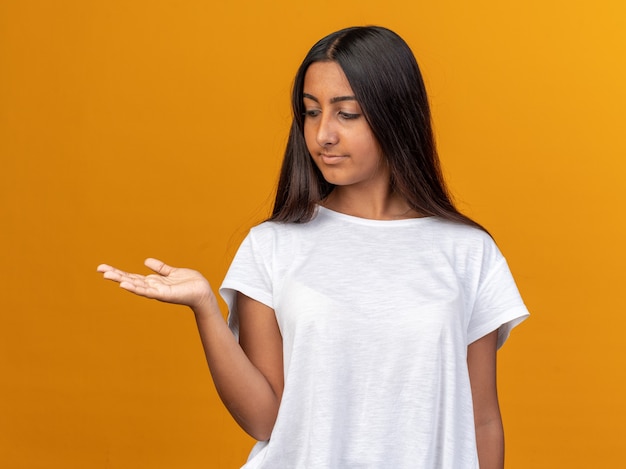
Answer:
98;62;504;469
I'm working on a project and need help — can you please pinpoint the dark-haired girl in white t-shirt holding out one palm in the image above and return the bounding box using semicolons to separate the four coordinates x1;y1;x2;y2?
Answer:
98;27;528;469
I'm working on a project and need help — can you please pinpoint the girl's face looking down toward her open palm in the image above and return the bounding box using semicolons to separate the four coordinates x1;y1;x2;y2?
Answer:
303;62;389;192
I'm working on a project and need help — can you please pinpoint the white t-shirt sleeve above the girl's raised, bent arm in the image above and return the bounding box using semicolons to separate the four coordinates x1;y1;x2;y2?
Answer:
219;229;274;337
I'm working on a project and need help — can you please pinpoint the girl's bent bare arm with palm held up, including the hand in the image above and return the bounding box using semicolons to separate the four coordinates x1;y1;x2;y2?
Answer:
98;259;283;440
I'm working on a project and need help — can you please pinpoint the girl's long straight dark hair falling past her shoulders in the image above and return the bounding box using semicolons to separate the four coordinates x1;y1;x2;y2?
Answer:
270;26;482;229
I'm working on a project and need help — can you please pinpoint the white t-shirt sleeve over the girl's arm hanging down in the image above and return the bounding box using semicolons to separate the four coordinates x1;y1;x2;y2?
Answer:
467;244;529;348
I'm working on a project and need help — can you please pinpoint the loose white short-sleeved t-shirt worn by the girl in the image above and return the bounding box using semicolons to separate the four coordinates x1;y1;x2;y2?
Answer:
220;207;528;469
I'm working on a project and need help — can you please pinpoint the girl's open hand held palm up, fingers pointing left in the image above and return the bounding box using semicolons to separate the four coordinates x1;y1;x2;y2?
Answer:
97;258;217;310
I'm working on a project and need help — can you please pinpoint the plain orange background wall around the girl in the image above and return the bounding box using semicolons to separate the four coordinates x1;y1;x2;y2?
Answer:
0;0;626;469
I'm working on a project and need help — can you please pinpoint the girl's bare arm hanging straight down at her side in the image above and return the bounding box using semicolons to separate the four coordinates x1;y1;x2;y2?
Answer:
467;330;504;469
